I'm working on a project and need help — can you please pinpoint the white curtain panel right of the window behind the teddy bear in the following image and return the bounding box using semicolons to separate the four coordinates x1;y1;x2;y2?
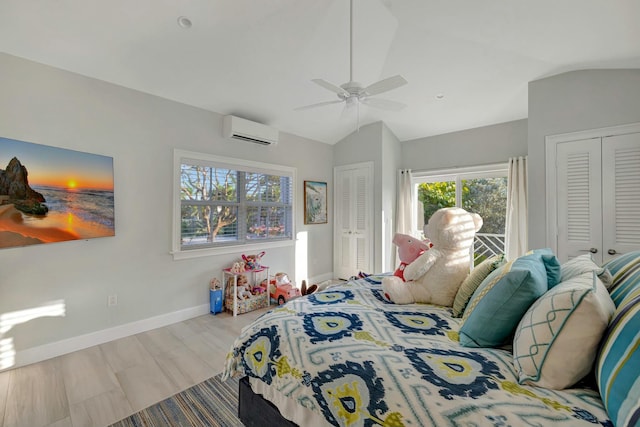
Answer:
504;157;529;260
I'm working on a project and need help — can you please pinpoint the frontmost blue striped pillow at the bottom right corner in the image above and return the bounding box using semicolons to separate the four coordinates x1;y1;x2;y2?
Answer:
596;288;640;426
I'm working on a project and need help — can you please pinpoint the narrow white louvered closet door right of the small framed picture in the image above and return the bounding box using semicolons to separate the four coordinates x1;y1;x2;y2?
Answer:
334;167;373;279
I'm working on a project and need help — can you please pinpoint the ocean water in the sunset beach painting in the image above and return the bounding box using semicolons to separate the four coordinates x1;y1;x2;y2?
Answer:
33;186;115;229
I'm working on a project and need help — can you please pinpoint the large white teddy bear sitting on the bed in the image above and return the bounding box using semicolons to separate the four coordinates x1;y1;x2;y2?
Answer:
382;208;482;307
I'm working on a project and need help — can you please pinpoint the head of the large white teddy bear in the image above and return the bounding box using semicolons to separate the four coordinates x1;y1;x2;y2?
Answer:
424;208;482;249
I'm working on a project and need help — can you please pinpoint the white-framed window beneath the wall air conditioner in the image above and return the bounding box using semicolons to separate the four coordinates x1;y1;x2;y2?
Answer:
173;150;295;258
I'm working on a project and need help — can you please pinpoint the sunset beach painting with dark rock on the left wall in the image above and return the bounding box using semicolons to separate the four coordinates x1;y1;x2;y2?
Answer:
0;137;115;248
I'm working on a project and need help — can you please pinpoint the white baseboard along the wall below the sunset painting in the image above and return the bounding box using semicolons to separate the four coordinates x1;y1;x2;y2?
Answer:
9;304;210;369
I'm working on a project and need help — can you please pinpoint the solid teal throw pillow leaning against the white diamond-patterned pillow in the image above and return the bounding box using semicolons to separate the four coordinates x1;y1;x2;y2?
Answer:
459;253;548;347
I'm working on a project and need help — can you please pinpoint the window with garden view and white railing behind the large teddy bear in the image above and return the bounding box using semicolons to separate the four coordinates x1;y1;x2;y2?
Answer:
412;164;508;265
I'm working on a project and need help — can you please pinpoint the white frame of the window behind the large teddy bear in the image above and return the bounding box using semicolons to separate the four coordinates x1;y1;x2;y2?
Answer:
411;163;509;236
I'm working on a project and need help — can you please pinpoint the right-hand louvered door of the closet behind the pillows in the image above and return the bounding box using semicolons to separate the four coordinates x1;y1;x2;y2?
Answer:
602;133;640;261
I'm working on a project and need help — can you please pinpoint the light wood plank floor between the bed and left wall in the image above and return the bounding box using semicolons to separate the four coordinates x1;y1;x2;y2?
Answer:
0;309;267;427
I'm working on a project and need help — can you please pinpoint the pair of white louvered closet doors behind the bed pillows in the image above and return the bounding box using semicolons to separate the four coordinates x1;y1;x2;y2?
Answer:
546;125;640;264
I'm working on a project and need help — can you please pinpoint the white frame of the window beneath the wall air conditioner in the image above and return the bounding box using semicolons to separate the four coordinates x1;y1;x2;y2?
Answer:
171;148;297;260
